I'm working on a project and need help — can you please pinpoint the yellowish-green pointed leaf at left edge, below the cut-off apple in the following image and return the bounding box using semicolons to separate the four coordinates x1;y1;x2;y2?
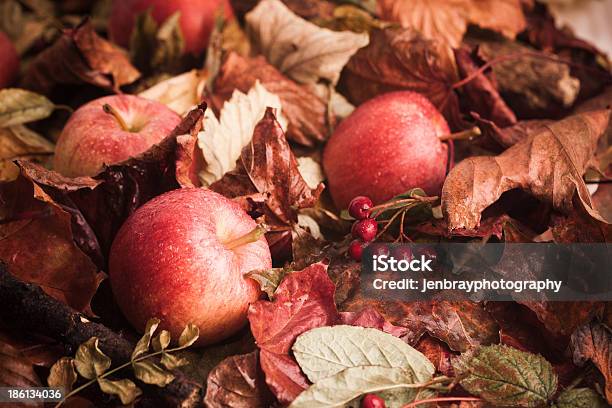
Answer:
0;88;55;127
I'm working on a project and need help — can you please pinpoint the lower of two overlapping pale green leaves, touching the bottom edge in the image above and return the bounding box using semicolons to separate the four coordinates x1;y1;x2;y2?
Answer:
289;366;419;408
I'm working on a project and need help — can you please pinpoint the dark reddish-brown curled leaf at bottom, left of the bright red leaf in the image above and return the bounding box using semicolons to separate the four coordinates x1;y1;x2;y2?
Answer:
204;351;271;408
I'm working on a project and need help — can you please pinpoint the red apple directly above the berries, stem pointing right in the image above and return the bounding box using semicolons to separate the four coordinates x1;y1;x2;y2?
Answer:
323;91;450;208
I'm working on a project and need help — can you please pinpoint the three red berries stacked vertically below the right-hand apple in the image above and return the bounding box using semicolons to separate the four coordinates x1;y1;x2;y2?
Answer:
348;196;378;261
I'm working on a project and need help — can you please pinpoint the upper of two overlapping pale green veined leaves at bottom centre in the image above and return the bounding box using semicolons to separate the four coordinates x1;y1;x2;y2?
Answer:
293;325;435;383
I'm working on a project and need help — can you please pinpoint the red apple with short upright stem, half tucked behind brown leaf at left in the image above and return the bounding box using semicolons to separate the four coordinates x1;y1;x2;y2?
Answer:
54;95;181;177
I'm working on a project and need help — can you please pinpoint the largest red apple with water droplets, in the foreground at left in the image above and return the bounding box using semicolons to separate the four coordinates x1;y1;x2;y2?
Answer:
109;188;272;345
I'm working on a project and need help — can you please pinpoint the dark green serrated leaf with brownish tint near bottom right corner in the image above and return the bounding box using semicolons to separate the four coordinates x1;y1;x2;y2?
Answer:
454;345;557;407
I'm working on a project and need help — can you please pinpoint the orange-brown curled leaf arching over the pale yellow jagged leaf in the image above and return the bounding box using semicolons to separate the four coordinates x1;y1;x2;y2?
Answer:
212;53;334;146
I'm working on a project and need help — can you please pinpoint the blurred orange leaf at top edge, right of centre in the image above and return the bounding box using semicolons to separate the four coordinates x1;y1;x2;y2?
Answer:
378;0;526;48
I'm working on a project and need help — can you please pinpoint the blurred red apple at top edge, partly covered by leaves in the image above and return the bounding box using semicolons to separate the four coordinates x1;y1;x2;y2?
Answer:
108;0;233;54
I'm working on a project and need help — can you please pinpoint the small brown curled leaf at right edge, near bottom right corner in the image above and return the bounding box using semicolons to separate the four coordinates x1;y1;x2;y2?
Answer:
570;323;612;404
